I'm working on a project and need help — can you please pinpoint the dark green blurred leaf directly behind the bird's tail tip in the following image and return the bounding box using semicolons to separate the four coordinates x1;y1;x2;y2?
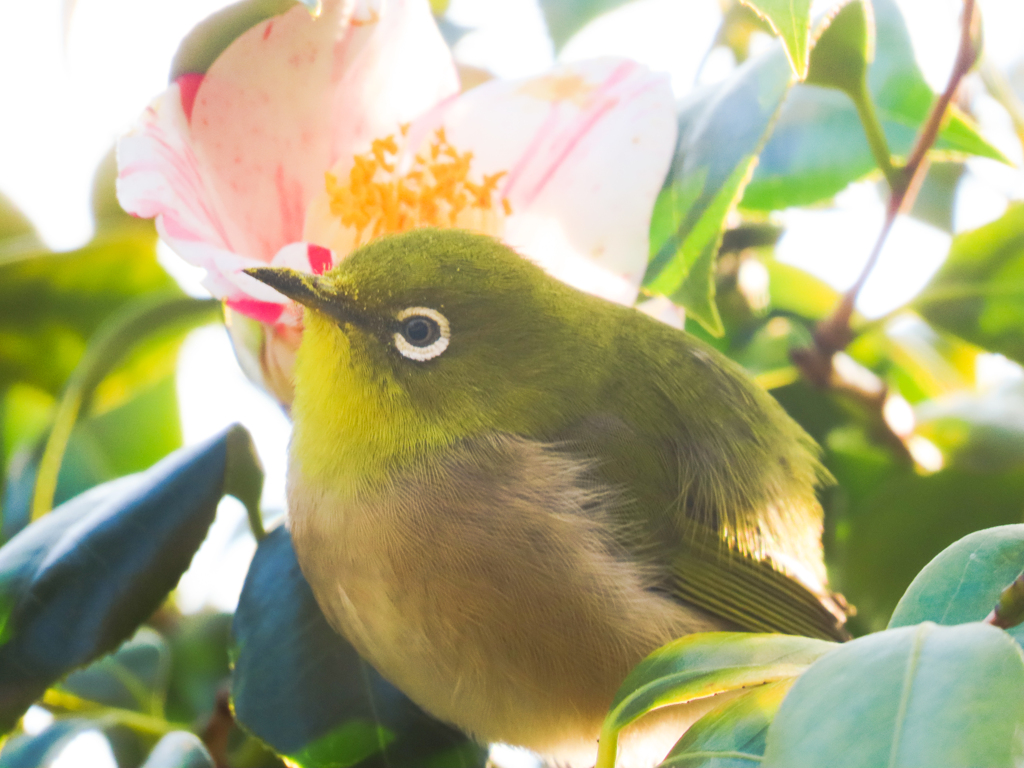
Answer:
826;430;1024;630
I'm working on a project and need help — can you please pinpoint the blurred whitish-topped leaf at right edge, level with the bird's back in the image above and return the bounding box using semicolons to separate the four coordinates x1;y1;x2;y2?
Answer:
915;381;1024;472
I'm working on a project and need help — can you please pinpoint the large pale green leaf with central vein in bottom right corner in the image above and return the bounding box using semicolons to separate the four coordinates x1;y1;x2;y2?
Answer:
762;623;1024;768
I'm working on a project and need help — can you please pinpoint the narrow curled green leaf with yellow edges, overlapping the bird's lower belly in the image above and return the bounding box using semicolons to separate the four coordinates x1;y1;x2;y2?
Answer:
597;632;837;768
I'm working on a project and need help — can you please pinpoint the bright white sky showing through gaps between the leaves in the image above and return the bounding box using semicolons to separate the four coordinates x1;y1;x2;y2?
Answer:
0;0;1024;766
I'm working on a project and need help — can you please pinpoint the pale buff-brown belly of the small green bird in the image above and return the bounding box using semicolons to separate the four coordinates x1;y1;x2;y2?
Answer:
289;443;722;766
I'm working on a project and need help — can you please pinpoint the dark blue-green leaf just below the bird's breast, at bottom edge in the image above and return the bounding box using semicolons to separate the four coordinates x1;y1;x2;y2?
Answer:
231;527;486;768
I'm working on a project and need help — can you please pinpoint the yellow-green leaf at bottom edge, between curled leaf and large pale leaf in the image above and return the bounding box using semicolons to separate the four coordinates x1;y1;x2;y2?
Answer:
659;679;794;768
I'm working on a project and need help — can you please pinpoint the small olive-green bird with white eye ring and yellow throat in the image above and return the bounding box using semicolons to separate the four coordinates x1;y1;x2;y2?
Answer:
248;229;845;767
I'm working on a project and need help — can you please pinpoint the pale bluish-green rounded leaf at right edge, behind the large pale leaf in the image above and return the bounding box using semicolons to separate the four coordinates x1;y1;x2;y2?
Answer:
889;524;1024;643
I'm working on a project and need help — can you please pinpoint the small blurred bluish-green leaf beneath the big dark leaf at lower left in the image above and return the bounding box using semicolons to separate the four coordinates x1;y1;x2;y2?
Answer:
57;627;170;717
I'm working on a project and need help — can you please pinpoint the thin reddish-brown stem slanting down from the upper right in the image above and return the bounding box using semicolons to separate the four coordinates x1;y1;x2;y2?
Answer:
792;0;981;453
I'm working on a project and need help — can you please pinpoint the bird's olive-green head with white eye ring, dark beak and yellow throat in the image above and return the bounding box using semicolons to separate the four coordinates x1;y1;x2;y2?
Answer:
247;229;612;489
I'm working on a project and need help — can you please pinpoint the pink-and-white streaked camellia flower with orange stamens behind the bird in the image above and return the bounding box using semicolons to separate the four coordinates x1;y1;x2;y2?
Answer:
118;0;676;407
